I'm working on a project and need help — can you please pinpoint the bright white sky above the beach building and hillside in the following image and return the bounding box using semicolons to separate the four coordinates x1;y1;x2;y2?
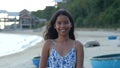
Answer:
0;0;55;12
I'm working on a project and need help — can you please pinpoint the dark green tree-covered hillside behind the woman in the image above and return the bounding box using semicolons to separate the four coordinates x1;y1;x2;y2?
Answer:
32;0;120;28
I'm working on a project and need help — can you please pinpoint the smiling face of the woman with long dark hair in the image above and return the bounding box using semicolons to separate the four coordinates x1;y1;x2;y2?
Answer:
54;15;72;36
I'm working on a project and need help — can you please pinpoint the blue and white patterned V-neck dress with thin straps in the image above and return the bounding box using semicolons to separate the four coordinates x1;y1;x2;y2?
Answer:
49;41;76;68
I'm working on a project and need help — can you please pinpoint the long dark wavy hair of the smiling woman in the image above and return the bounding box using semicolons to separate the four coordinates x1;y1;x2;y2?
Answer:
44;9;75;40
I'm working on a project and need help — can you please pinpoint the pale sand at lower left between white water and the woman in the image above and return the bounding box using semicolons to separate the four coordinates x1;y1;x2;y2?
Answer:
0;41;43;68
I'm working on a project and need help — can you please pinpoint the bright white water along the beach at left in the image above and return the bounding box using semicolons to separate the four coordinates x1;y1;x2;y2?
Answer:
0;33;43;57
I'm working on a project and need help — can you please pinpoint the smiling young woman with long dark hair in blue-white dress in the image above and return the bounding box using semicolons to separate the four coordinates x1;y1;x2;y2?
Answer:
39;9;84;68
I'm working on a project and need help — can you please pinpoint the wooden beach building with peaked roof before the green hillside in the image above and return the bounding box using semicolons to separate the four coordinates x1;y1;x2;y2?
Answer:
19;9;47;29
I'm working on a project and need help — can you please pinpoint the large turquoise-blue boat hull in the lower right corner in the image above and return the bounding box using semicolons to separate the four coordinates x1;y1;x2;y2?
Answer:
91;54;120;68
